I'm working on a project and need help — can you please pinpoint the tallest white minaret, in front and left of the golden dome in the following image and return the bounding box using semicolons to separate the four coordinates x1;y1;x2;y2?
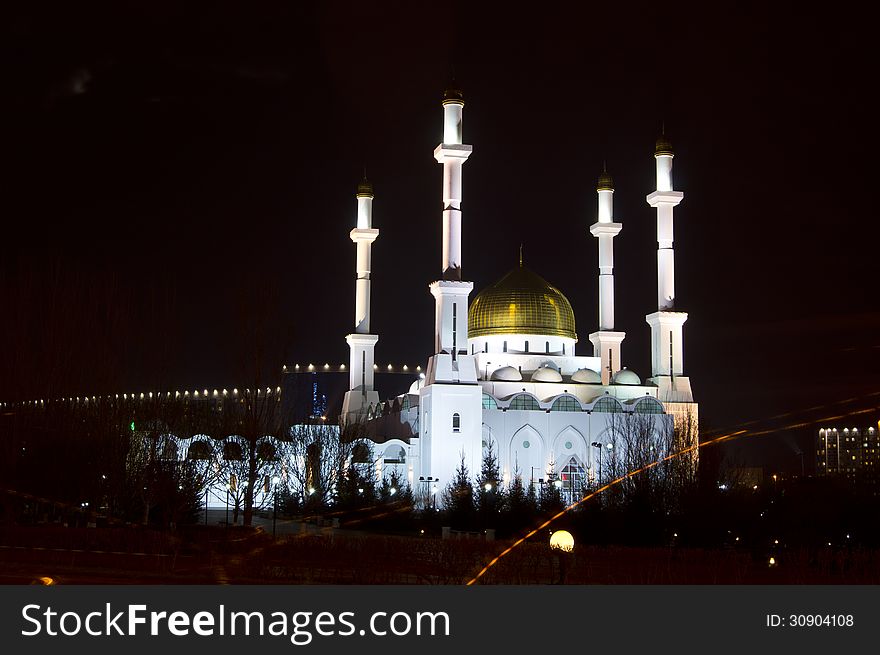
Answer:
427;89;474;383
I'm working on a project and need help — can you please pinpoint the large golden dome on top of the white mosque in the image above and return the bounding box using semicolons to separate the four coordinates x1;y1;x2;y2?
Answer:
468;266;577;341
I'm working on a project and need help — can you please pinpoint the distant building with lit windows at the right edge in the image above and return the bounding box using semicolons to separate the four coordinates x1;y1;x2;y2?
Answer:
816;427;880;487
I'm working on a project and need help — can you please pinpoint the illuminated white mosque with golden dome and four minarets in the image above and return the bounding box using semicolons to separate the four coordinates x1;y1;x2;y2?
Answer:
342;90;697;504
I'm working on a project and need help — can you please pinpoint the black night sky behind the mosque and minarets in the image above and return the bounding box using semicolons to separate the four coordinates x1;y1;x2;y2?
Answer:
0;1;880;472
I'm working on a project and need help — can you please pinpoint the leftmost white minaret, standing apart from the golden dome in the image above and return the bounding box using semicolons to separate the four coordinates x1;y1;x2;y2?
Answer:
342;174;379;420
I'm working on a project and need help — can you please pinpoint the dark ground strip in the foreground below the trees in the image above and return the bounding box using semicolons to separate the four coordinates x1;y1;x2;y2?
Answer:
0;516;880;584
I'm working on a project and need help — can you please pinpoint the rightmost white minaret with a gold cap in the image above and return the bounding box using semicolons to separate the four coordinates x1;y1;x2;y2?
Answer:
645;134;690;393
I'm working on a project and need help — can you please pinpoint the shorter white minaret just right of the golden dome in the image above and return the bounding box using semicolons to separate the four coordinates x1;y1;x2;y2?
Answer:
590;169;626;384
